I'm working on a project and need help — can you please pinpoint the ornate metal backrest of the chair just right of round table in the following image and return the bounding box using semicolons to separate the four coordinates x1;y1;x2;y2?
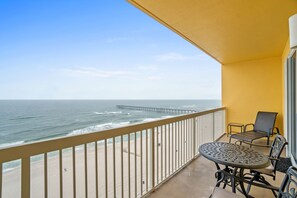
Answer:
269;135;287;171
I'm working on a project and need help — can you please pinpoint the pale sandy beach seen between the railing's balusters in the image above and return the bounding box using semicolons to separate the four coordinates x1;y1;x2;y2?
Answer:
3;124;193;198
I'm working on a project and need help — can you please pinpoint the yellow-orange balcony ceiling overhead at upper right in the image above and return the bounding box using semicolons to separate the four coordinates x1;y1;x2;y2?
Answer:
128;0;297;64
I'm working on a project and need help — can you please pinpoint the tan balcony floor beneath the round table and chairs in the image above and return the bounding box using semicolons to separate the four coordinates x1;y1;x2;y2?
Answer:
149;136;285;198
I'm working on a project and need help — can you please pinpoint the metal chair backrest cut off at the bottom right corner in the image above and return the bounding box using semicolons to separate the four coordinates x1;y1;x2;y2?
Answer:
277;166;297;198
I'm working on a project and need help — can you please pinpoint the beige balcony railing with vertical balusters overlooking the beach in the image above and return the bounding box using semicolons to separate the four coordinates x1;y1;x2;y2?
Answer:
0;108;225;198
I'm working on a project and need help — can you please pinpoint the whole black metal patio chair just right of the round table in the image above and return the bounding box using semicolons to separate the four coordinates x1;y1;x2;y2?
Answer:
245;135;288;195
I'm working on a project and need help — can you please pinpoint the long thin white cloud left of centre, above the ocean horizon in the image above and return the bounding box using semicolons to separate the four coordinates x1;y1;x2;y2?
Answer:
61;67;135;78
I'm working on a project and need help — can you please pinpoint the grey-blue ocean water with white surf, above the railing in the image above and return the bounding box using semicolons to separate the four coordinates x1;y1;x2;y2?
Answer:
0;100;221;147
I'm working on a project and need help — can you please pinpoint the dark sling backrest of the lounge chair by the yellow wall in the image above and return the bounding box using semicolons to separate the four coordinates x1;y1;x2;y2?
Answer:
254;111;277;133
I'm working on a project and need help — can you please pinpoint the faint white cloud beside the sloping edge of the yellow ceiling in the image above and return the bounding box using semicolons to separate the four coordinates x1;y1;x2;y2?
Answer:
156;52;209;61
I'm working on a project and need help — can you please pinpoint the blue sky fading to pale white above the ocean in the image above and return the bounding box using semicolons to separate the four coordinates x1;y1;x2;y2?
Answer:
0;0;221;99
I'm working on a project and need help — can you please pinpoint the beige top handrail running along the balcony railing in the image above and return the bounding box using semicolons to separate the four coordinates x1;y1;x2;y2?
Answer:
0;107;226;163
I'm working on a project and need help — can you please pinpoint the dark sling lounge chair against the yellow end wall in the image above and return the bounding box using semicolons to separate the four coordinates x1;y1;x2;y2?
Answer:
229;111;279;146
